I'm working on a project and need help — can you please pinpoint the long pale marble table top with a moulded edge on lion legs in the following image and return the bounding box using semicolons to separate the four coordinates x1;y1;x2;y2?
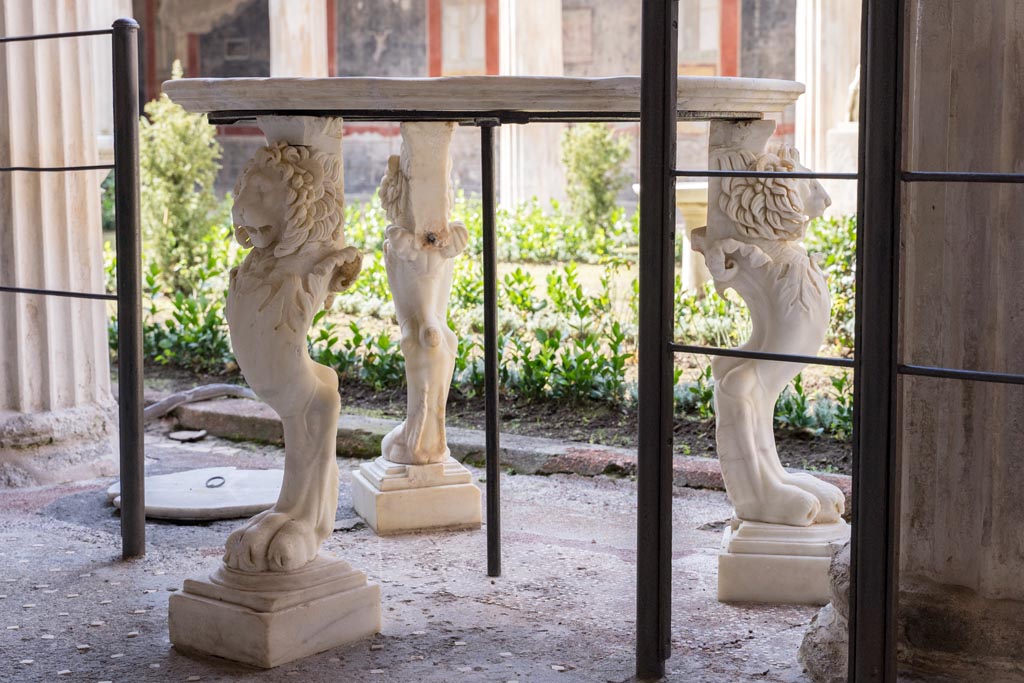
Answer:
164;76;804;123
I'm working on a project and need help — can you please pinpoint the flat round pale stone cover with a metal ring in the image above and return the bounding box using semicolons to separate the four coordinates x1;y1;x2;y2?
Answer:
106;467;285;521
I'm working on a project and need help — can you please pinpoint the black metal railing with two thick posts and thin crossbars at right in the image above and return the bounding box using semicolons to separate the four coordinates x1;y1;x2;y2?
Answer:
637;0;1024;683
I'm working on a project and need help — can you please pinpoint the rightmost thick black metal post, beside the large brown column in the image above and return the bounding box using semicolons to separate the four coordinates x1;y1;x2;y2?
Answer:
849;0;904;683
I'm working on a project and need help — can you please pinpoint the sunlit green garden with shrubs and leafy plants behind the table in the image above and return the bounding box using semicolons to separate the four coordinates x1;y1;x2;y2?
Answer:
104;78;855;472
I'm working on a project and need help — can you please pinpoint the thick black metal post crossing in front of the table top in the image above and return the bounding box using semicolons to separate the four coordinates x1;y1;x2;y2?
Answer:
637;0;678;679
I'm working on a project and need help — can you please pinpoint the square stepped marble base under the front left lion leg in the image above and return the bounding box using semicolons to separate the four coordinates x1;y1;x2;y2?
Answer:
168;555;381;669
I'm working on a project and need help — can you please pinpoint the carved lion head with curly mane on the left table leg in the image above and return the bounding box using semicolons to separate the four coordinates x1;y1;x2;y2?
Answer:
232;142;344;257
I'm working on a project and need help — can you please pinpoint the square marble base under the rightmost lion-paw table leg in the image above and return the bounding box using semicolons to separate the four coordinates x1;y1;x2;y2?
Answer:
718;519;850;605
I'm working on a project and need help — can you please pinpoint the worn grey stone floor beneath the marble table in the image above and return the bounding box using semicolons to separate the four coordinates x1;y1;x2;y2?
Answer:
0;432;815;683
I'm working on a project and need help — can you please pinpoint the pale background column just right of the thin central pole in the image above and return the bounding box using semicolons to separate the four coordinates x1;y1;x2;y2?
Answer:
499;0;565;206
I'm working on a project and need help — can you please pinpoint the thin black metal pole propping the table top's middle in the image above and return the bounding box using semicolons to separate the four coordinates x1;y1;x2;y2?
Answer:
480;121;502;577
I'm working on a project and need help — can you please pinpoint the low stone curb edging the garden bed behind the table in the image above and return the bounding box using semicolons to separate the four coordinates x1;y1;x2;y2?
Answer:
175;398;852;513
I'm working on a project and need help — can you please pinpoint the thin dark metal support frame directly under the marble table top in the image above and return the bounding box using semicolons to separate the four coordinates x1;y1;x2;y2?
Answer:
207;109;763;126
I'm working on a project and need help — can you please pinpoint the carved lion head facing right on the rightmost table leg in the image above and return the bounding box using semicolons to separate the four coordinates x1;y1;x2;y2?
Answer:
714;145;831;240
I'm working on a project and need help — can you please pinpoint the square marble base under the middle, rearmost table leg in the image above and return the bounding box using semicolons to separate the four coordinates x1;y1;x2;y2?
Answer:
352;457;480;536
